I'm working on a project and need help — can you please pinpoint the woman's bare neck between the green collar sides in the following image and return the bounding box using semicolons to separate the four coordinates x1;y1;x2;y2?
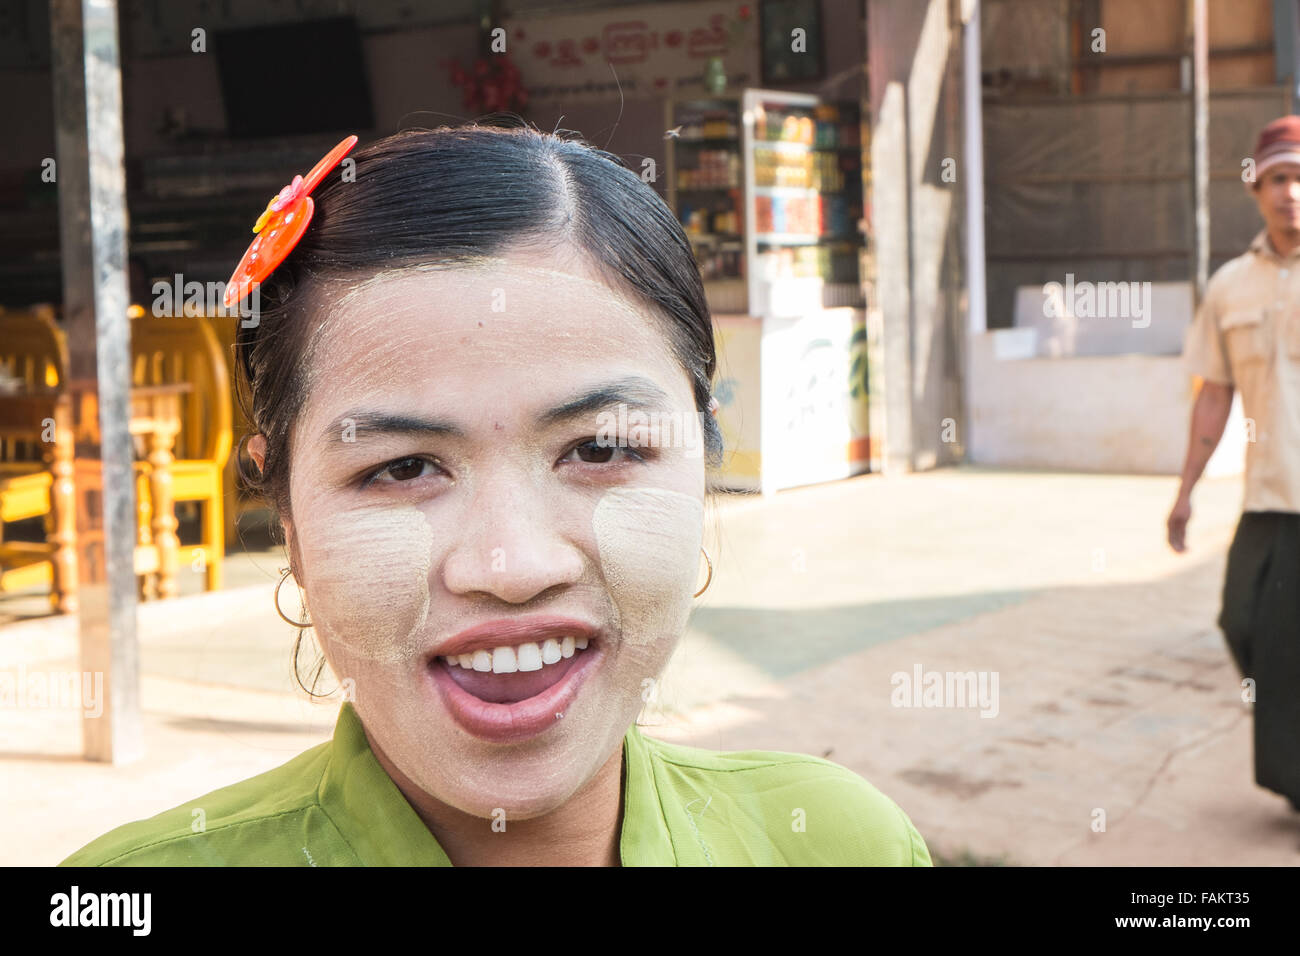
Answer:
367;735;623;866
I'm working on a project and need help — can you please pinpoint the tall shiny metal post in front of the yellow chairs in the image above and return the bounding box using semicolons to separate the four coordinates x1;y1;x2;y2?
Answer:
49;0;144;763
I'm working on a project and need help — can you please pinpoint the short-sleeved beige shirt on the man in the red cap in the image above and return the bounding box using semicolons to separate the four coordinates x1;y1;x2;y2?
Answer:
1183;232;1300;511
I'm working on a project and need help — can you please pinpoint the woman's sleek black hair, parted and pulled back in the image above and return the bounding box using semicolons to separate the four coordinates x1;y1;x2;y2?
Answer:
235;124;722;514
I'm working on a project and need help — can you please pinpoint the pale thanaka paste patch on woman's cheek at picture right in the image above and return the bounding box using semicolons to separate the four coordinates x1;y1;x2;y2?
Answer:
592;488;705;646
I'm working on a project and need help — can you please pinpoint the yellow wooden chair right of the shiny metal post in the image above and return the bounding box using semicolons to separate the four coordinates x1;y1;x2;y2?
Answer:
131;310;230;591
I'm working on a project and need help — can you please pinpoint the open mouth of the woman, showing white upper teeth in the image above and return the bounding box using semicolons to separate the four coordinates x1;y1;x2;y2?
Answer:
428;635;605;743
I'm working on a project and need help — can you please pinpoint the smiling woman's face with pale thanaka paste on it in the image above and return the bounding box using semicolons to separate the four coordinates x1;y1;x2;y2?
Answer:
285;248;705;819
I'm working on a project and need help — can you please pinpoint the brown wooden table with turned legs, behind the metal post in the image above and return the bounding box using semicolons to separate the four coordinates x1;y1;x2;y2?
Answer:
0;382;192;613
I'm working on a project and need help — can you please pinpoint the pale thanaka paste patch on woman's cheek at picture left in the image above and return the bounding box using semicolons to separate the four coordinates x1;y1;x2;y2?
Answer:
300;505;433;663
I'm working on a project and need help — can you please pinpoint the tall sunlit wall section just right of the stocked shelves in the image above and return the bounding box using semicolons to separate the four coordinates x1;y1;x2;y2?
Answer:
867;0;966;472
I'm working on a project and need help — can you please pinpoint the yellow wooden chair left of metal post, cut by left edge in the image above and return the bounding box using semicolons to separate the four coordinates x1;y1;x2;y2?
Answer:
0;304;77;611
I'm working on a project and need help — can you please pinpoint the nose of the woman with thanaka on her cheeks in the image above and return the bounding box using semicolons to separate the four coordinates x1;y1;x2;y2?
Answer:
442;468;585;604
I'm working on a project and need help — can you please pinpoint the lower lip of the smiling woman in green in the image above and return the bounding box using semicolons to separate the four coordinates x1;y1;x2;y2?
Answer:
428;644;603;744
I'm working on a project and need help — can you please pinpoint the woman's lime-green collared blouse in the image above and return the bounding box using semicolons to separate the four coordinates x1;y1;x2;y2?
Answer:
60;702;931;866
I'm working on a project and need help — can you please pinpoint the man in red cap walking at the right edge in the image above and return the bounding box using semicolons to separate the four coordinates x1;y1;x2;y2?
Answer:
1169;116;1300;810
